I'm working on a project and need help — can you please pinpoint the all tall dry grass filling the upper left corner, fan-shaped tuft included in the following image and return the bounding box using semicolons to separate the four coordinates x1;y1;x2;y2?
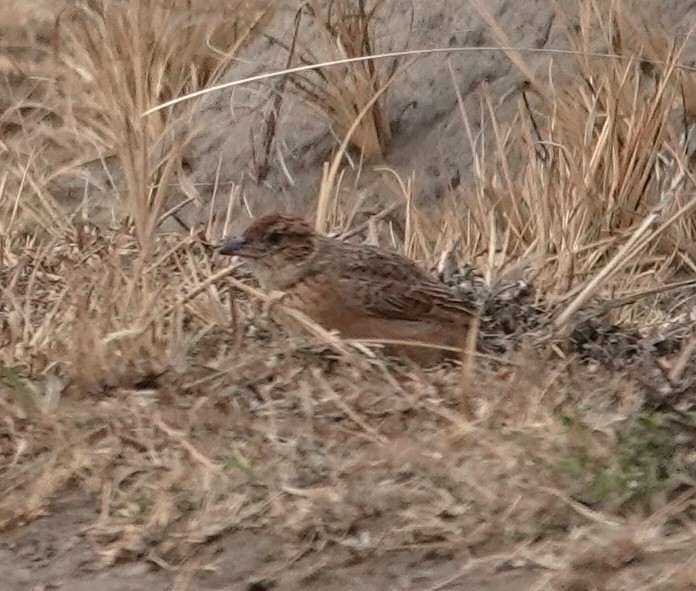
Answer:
1;0;269;253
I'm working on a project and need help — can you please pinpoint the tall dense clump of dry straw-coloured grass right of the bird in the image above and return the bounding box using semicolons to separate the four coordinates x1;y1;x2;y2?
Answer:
453;2;694;306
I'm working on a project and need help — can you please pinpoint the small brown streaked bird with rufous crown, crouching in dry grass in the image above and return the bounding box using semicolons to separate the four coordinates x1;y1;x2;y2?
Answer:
219;213;476;364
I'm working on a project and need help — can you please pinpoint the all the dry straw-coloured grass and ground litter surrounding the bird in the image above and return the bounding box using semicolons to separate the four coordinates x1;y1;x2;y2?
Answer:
0;1;696;584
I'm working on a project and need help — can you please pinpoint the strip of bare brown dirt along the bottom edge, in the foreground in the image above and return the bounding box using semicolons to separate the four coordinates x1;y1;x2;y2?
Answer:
0;492;696;591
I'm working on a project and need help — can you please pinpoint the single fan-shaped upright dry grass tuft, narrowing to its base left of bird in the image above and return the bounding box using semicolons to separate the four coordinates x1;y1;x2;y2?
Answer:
58;0;269;249
